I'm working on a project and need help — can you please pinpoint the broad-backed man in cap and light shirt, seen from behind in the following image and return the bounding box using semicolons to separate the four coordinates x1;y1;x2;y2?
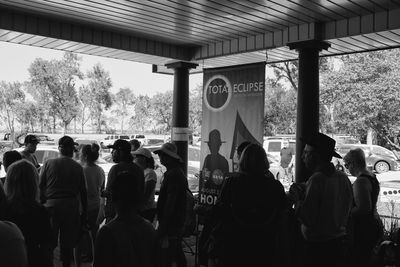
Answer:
39;136;87;266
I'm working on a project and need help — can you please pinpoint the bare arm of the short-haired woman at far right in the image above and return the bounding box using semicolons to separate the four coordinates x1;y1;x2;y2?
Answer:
351;178;372;216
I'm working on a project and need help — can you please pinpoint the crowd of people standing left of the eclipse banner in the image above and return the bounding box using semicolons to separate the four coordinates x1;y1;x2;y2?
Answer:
0;135;188;267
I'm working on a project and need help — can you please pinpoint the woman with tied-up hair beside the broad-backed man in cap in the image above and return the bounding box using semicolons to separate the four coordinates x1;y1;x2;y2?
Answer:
75;143;105;266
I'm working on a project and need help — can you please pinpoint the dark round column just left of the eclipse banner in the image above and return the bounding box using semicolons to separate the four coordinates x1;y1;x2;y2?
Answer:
165;61;198;173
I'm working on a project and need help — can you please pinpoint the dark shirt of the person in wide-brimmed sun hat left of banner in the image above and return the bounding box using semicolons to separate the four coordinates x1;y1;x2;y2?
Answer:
157;167;188;234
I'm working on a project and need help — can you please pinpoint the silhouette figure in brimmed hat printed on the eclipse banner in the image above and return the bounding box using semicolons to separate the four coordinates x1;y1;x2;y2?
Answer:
202;129;229;189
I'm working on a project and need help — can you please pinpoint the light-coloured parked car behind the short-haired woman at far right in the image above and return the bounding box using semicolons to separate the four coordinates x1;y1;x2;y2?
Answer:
336;144;400;173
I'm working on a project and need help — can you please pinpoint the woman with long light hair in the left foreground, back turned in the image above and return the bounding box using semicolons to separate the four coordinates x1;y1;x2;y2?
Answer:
4;160;54;266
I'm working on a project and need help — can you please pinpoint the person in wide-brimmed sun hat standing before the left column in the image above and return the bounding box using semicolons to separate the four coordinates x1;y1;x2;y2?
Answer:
154;143;188;267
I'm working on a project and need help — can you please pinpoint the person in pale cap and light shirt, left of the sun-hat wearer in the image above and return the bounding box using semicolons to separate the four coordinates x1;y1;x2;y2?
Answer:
132;147;157;223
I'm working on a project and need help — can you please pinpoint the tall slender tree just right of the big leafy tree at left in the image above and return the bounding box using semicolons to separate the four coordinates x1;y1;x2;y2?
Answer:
87;63;112;133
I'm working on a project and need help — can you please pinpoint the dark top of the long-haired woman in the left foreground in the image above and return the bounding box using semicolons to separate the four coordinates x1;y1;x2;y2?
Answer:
6;203;52;266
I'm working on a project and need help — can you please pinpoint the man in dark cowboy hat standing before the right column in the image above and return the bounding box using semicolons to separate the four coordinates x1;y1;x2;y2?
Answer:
289;133;353;267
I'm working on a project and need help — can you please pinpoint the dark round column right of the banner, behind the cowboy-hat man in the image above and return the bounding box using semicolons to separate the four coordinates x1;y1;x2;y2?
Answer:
288;40;330;182
